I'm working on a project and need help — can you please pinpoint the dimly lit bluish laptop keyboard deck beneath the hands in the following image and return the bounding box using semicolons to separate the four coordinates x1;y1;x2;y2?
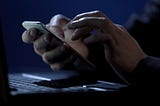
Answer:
8;74;126;93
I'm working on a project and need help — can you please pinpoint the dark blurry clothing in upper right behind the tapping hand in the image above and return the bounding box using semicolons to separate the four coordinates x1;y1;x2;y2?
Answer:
124;0;160;57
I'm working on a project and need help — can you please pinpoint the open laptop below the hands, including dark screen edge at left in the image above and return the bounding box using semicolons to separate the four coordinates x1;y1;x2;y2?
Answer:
0;18;127;104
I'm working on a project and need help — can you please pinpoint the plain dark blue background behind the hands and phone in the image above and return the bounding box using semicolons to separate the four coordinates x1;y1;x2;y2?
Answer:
0;0;147;72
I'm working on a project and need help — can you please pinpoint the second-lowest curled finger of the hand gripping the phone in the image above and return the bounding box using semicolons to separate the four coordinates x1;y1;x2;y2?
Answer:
42;46;71;64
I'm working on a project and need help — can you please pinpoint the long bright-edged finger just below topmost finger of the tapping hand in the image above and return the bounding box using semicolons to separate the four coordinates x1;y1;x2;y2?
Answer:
70;17;122;44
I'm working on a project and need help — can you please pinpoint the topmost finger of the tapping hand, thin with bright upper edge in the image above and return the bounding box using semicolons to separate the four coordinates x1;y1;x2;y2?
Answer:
71;10;105;21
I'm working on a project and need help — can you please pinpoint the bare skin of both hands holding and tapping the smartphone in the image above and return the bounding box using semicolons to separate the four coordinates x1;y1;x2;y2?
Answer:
22;11;147;73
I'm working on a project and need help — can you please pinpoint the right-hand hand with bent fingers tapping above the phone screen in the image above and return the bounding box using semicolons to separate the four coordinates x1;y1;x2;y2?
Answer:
68;11;146;72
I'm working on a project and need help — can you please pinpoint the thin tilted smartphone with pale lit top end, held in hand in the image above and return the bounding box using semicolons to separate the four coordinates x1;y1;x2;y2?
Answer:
22;21;96;70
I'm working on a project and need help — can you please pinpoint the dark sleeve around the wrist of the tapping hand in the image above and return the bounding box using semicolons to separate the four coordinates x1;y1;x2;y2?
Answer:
131;56;160;88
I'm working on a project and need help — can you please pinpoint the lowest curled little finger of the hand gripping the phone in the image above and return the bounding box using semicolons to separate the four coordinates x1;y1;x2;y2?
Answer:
50;55;76;70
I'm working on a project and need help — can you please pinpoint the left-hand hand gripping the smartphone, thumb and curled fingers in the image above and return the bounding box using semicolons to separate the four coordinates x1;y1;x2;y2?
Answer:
22;15;88;70
